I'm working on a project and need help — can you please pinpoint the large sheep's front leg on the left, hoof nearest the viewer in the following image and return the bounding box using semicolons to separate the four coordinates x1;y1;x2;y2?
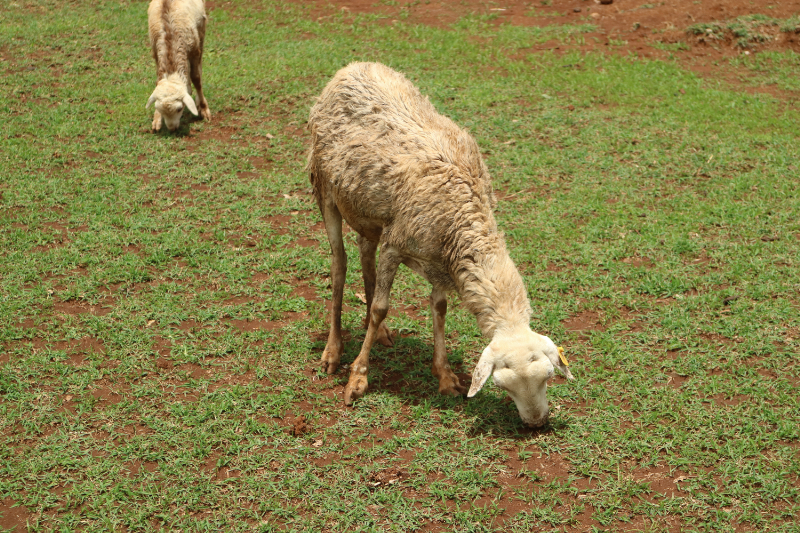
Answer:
344;245;400;405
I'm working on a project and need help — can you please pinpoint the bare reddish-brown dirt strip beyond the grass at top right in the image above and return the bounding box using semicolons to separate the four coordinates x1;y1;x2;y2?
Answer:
296;0;800;101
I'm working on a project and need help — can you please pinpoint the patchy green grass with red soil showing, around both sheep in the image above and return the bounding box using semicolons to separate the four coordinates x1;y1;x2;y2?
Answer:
0;1;800;531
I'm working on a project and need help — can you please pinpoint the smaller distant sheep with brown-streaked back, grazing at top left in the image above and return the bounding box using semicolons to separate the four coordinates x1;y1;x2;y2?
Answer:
145;0;211;131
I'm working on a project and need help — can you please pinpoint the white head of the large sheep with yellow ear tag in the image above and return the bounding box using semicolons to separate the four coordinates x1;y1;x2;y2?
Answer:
467;325;574;427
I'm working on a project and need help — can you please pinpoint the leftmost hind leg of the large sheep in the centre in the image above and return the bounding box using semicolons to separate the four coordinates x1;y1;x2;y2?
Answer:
320;200;347;374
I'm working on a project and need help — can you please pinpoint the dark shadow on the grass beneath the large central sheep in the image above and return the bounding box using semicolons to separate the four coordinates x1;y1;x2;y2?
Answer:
322;334;568;441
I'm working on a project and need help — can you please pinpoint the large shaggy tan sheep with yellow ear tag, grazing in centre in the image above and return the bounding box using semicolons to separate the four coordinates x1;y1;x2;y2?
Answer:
307;63;572;427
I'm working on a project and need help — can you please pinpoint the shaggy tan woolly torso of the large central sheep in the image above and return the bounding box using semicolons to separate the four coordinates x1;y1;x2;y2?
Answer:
308;63;503;270
